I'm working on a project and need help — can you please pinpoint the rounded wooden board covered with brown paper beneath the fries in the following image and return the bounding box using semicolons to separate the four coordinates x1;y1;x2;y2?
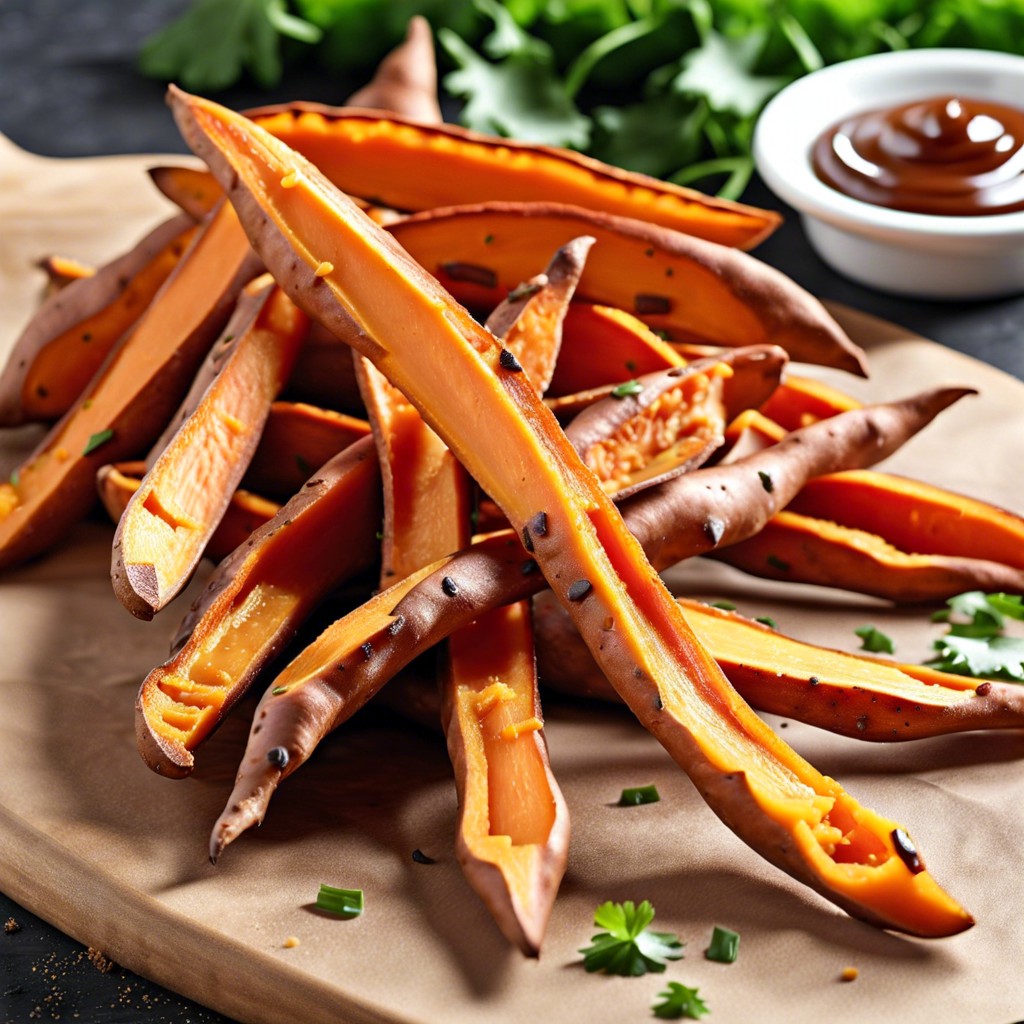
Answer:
0;142;1024;1024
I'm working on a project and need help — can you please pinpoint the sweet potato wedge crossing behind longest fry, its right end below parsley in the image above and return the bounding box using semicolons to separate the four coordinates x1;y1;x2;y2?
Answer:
536;594;1024;742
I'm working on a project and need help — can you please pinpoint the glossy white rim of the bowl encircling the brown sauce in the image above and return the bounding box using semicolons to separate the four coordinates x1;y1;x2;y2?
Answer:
753;47;1024;244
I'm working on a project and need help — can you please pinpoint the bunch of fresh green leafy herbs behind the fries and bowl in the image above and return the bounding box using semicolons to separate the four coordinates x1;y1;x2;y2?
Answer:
140;0;1024;196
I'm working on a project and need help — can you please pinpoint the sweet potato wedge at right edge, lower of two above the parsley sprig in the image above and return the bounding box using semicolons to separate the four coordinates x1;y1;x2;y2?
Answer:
714;510;1024;604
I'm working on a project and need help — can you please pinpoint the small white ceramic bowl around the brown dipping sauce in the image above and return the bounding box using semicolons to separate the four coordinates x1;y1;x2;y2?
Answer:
754;49;1024;299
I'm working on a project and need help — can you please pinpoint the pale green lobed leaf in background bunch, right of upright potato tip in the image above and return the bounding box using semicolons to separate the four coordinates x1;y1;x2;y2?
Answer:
437;29;591;150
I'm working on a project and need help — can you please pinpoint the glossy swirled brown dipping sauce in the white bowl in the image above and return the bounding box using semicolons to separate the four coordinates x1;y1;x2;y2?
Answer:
812;96;1024;217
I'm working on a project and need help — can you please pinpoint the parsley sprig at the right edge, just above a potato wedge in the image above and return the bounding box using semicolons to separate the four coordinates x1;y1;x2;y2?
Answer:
928;591;1024;683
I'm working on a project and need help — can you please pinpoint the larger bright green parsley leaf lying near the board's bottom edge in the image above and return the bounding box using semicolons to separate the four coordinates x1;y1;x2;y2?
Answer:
580;900;683;977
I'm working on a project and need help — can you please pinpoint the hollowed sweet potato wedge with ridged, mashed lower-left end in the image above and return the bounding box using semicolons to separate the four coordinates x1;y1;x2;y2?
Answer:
135;437;380;778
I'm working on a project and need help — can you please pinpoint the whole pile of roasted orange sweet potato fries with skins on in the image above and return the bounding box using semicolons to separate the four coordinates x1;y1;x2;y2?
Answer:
0;22;1024;954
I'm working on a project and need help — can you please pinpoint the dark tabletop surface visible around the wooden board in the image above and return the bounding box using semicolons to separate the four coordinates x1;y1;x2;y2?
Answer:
0;0;1024;1024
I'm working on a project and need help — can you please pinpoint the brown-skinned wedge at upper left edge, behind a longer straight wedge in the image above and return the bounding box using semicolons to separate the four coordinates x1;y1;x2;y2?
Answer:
0;217;196;426
